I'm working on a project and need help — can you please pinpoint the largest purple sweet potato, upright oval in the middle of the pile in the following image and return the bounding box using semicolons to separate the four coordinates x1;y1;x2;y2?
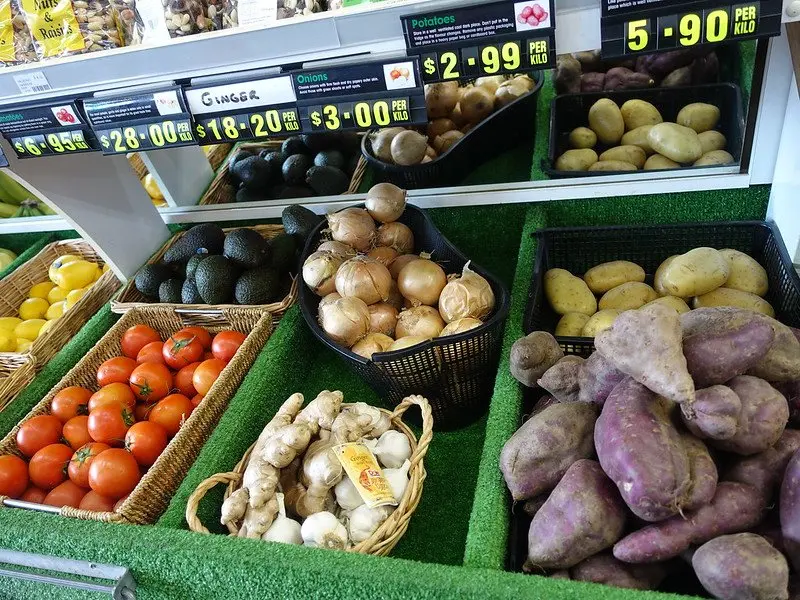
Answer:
594;380;692;521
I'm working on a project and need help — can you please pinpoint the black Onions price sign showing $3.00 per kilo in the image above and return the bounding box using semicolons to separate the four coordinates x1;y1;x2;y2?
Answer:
291;59;428;132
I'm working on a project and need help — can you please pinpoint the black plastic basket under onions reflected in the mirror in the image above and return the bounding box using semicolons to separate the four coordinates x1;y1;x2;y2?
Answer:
361;71;543;190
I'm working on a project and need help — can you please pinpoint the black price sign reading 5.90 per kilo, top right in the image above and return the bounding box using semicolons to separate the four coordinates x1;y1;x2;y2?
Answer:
601;0;783;58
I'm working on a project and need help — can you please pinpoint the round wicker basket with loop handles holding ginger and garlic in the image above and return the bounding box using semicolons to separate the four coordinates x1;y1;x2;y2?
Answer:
186;396;433;556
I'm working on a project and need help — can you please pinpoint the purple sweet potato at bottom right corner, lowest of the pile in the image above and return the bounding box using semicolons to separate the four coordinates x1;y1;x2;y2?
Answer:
692;533;789;600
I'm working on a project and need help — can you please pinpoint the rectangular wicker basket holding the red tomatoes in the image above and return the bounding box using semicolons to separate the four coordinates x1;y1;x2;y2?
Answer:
0;306;272;525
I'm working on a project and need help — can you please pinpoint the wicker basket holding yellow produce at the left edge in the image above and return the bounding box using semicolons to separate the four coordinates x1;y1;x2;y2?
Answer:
0;240;120;371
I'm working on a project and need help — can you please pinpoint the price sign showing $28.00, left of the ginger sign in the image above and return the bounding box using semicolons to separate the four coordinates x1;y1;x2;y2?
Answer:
84;86;197;154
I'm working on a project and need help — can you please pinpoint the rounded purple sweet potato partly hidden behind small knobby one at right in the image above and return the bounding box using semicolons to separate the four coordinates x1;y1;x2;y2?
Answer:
709;375;789;456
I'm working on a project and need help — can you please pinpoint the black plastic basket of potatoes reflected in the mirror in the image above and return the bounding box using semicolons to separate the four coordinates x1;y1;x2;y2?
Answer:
542;83;744;179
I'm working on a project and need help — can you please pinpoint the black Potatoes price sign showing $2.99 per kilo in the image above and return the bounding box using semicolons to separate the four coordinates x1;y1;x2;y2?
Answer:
401;0;556;83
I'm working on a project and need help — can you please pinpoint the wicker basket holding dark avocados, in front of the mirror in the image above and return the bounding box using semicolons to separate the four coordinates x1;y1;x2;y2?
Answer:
111;225;297;322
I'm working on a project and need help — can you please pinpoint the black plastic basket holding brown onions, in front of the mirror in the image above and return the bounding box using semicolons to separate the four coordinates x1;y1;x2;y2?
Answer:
300;205;509;429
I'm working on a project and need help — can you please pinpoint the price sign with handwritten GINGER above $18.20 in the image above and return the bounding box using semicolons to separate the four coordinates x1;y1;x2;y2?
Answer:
186;76;301;145
